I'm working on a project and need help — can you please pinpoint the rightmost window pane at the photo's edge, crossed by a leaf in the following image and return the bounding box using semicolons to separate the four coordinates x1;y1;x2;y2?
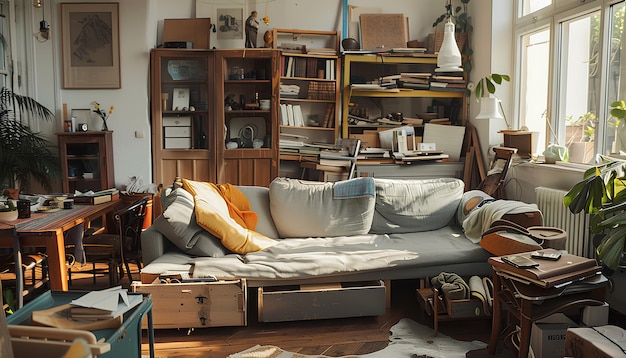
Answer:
604;2;626;154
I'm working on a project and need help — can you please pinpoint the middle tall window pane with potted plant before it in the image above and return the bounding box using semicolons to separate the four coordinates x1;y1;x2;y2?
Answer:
558;11;600;163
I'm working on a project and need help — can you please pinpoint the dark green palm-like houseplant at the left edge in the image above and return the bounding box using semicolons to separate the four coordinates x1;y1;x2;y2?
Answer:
0;87;60;190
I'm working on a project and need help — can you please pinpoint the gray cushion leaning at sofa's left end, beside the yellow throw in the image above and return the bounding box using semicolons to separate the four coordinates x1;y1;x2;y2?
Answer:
153;188;229;257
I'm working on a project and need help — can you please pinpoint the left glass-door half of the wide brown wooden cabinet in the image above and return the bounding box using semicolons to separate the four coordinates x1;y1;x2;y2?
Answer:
151;49;215;189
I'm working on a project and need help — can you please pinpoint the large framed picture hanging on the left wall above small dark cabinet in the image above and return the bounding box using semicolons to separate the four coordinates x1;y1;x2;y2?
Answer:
61;3;122;89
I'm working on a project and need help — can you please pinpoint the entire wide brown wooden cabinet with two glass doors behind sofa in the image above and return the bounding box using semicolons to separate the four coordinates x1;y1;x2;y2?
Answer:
151;49;278;186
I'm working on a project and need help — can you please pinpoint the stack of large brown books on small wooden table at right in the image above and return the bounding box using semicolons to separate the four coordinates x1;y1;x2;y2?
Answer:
489;249;601;288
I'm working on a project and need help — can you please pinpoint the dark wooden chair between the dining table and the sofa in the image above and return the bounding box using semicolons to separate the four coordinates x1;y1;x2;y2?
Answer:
74;197;150;286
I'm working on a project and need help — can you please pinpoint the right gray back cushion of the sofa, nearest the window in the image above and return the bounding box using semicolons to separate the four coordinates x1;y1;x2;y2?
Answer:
370;178;464;234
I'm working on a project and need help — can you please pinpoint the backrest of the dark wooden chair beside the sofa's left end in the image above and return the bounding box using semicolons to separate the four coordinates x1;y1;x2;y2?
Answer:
113;196;150;256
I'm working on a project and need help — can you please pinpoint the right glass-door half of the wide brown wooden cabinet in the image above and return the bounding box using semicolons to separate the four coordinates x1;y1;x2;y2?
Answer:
214;49;278;186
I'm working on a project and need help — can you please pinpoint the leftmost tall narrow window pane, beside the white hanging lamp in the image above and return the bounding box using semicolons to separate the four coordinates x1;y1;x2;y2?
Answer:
519;29;550;153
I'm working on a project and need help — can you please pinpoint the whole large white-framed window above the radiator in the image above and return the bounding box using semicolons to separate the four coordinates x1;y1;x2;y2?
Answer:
515;0;626;163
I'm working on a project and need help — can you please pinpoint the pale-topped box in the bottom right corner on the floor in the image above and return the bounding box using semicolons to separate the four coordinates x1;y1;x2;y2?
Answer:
565;325;626;358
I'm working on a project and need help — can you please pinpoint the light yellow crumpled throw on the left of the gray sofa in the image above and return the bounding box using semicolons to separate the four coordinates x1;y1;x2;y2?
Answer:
183;179;276;254
